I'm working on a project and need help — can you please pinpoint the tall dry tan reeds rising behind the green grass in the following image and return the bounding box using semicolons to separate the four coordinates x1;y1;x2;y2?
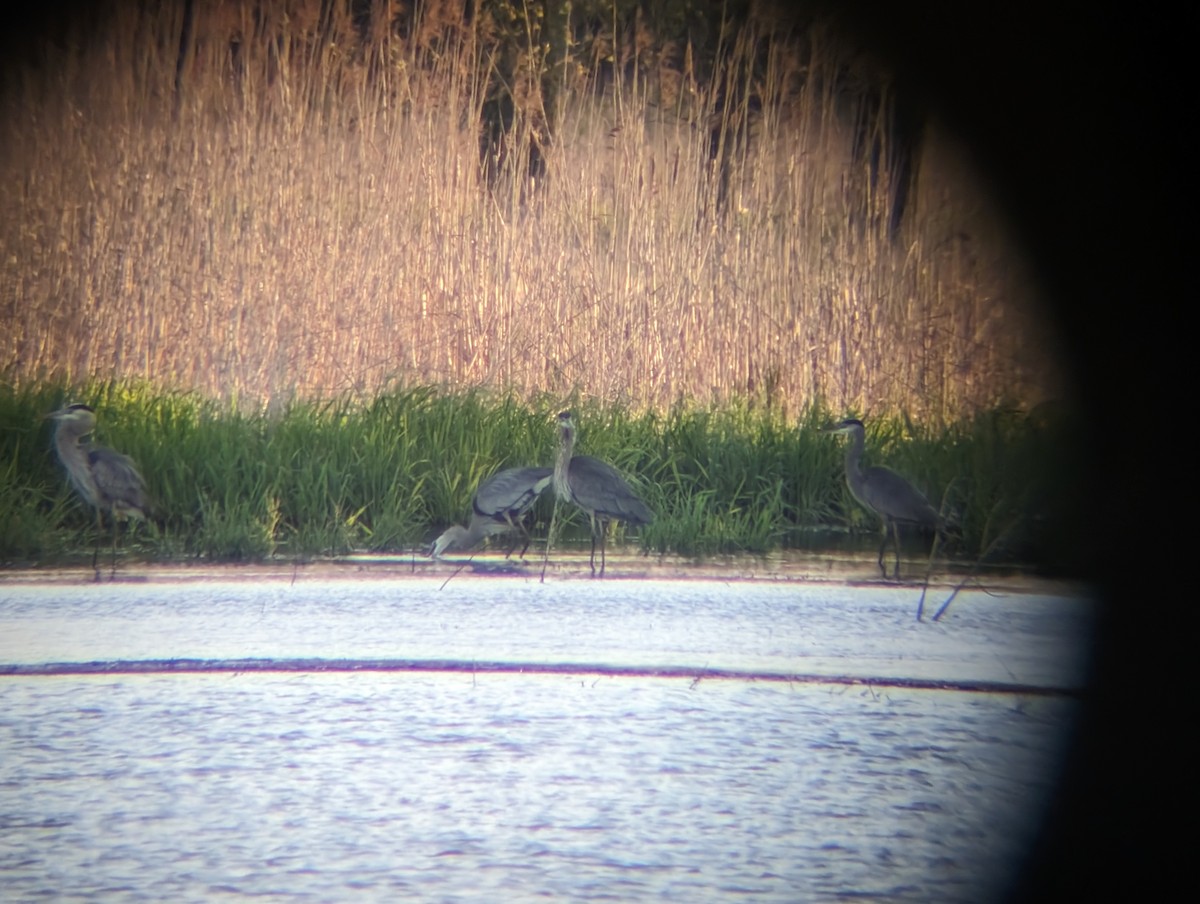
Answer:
0;2;1058;420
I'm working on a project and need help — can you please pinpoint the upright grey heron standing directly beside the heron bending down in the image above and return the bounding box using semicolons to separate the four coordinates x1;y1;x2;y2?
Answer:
554;412;654;577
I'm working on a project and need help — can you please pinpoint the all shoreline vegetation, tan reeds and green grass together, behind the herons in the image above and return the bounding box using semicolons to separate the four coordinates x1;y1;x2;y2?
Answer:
0;0;1074;564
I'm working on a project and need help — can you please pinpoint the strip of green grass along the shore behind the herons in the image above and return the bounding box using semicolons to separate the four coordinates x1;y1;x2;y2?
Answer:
0;383;1080;573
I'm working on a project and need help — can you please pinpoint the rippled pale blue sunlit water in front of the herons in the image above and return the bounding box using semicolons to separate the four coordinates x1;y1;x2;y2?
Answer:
0;566;1091;902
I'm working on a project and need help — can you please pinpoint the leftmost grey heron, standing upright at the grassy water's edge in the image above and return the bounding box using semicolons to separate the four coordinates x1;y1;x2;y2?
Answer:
46;405;150;576
